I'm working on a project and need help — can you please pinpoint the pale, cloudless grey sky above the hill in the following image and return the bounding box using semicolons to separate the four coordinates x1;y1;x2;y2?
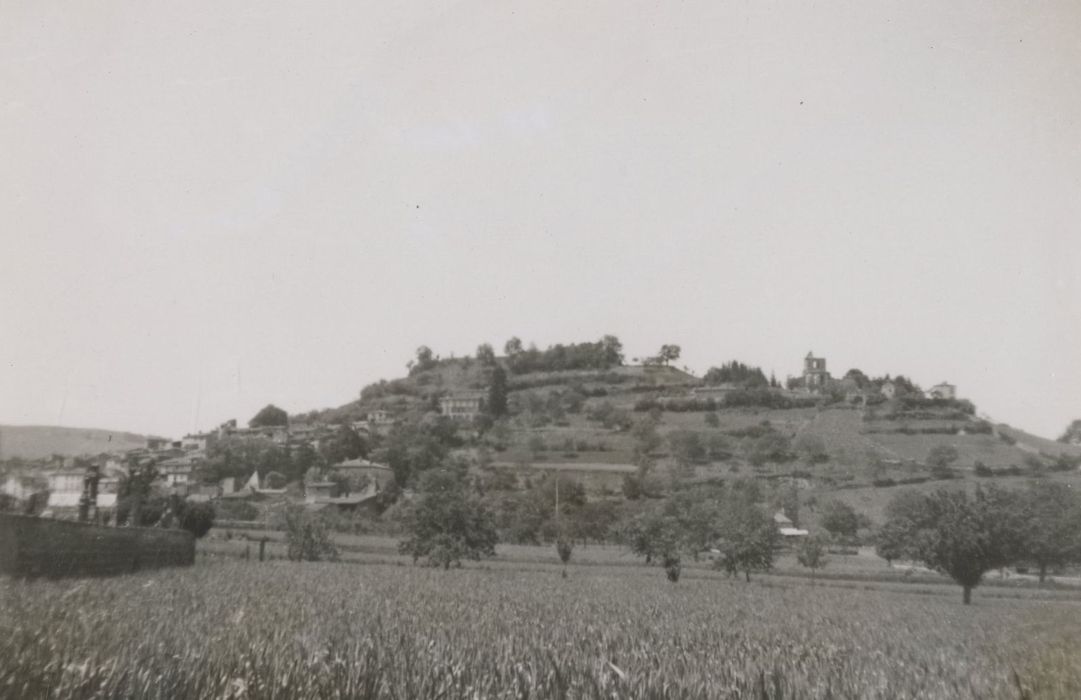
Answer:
0;0;1081;436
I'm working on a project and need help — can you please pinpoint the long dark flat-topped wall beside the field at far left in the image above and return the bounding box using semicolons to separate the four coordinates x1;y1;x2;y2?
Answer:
0;513;196;577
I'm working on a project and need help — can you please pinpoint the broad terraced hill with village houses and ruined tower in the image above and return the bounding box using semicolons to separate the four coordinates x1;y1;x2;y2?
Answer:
0;336;1081;541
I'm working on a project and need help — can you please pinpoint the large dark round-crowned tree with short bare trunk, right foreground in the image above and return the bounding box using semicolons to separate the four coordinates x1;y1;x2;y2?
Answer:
888;487;1024;605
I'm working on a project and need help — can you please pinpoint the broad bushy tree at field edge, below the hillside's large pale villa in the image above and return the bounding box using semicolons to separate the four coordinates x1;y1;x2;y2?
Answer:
398;469;498;569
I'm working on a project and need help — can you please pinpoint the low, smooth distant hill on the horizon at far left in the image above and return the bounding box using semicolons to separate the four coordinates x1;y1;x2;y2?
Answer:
0;426;152;459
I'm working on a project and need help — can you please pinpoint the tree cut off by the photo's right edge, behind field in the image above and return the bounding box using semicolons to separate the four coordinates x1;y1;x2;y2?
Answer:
1020;481;1081;583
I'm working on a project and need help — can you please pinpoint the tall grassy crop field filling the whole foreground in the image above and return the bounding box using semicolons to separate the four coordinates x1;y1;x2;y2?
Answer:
0;562;1081;699
